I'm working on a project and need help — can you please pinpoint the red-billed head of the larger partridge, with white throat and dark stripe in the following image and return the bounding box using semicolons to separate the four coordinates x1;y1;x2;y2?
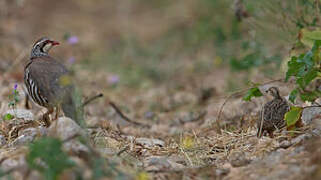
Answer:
30;37;59;59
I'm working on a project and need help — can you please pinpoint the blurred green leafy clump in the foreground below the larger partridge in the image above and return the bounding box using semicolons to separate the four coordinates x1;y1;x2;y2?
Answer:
26;137;75;180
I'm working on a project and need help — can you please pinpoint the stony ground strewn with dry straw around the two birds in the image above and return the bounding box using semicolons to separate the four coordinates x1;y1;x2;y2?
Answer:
0;73;321;179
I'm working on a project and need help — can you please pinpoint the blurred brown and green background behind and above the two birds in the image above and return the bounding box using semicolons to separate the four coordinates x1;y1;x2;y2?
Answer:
0;0;319;91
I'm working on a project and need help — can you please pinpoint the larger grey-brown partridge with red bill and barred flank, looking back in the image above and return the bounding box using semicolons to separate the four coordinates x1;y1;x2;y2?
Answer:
24;37;76;126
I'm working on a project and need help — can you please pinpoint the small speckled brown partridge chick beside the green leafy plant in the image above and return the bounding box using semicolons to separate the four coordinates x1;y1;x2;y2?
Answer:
257;87;290;138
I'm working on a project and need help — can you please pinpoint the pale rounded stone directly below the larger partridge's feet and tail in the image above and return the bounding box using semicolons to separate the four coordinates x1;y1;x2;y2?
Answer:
48;117;84;141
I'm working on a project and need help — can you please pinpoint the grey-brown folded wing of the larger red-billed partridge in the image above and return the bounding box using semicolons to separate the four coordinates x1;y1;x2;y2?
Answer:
26;57;72;105
